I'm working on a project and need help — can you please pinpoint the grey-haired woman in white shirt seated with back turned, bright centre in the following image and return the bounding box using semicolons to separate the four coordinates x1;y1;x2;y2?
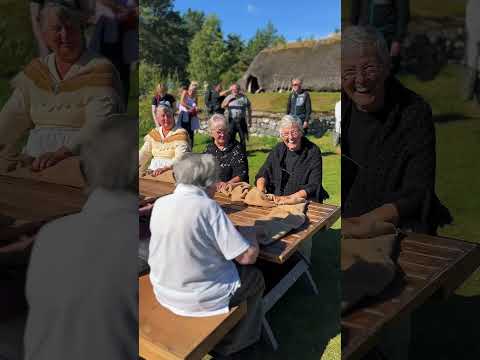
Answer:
148;154;264;355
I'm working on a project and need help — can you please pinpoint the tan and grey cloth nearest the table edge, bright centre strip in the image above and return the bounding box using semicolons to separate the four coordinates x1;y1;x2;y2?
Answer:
255;202;306;245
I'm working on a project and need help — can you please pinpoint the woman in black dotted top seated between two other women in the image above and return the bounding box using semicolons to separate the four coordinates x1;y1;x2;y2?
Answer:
205;114;248;190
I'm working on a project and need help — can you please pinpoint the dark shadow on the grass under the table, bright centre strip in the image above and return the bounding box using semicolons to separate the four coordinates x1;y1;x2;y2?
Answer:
249;229;340;360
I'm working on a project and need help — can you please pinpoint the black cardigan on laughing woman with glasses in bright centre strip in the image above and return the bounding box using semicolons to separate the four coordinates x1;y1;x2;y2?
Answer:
255;137;328;202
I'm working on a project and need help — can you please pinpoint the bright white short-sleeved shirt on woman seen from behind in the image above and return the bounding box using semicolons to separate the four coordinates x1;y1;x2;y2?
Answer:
148;184;250;317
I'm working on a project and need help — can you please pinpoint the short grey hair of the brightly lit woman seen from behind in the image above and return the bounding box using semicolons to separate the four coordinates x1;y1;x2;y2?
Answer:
173;153;220;190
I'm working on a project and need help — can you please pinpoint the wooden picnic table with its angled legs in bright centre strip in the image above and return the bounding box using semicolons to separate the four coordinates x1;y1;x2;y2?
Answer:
139;179;340;349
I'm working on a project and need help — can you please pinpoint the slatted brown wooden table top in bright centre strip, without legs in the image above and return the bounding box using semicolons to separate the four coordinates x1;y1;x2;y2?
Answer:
139;179;340;264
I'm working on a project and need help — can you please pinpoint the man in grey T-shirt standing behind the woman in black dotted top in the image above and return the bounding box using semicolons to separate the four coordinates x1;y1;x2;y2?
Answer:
222;84;252;151
